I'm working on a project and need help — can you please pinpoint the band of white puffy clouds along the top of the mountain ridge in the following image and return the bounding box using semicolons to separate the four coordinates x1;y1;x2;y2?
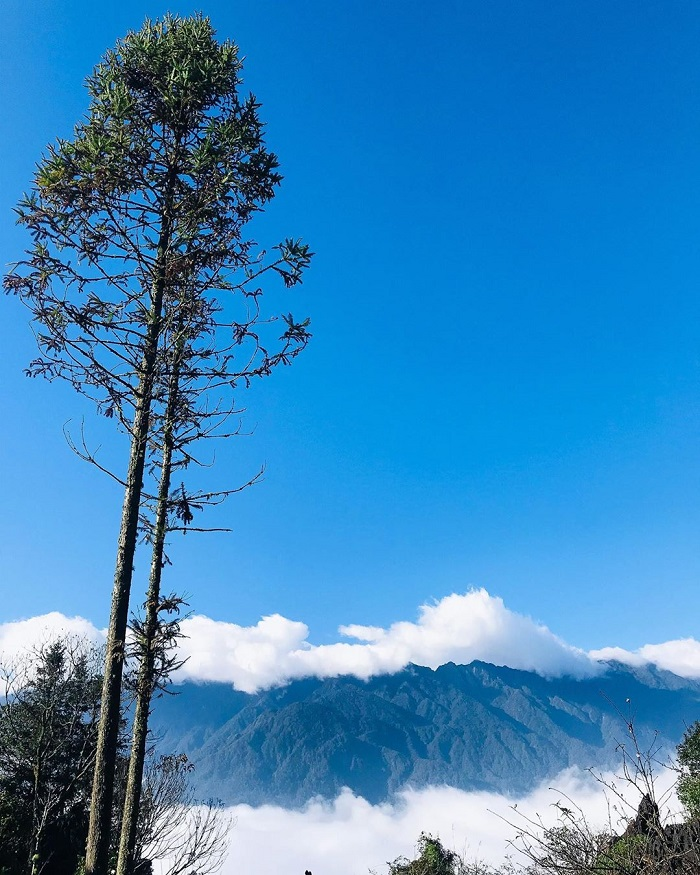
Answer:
0;589;700;692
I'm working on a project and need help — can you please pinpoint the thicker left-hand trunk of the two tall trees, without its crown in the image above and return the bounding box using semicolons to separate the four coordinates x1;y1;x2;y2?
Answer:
85;219;170;875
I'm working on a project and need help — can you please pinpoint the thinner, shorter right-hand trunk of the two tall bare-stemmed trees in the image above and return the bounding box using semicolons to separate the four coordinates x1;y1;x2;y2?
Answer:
117;339;182;875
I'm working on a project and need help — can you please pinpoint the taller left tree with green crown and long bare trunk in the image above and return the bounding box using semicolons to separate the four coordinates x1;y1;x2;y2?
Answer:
4;16;310;875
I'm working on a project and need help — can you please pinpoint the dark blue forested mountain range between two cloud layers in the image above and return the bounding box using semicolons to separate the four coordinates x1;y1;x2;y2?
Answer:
151;662;700;806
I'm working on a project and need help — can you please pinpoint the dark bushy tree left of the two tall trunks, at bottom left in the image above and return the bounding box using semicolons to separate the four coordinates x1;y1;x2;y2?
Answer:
0;640;101;875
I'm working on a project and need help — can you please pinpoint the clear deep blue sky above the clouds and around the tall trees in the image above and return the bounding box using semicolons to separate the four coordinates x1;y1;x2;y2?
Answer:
0;0;700;647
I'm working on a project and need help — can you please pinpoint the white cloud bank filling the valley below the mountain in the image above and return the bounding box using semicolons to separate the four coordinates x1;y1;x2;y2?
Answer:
172;769;673;875
